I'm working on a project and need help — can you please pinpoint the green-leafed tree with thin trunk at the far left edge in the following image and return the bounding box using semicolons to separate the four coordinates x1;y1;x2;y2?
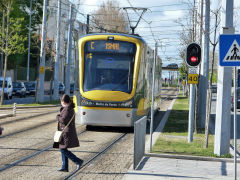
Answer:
0;0;27;105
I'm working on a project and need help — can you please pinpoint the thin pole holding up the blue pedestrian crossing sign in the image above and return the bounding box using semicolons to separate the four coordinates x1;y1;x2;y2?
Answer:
234;67;237;180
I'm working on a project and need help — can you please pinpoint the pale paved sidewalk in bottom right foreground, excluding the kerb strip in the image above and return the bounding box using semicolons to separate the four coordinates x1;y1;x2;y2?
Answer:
123;157;240;180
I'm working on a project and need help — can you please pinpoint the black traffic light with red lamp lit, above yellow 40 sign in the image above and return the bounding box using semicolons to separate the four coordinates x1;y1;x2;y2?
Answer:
186;43;201;67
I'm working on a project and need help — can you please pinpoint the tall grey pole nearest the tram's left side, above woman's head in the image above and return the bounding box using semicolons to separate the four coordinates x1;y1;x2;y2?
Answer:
65;4;72;94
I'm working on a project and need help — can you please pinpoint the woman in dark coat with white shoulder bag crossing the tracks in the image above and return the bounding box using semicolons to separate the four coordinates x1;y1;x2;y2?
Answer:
53;94;83;172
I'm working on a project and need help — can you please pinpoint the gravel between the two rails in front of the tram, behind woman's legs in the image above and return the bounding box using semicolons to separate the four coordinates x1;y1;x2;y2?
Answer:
0;129;125;180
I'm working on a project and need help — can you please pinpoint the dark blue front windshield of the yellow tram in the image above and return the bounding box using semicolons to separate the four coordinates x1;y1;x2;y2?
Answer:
84;53;134;93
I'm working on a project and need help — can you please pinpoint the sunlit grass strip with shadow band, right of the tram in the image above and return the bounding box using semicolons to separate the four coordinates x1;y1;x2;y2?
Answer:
152;95;231;157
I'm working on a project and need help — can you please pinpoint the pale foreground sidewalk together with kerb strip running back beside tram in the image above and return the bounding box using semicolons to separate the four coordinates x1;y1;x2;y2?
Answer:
122;93;240;180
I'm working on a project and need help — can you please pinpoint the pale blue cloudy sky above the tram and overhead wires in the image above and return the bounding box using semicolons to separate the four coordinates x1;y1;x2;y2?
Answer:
72;0;240;77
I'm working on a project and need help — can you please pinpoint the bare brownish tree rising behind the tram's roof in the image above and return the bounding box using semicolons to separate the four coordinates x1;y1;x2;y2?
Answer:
92;0;128;33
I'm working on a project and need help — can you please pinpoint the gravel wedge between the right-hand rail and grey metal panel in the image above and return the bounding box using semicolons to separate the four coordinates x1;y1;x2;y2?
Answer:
72;133;134;180
